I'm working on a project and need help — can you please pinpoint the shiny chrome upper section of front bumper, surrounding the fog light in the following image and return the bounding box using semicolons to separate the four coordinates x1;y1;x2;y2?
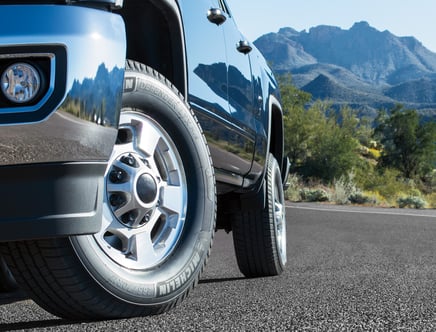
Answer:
0;5;126;166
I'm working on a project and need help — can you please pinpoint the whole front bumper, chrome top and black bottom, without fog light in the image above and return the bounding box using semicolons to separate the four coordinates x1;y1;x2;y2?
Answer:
0;5;126;241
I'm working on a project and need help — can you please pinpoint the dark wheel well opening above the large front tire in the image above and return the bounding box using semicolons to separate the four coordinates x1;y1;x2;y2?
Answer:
118;0;188;99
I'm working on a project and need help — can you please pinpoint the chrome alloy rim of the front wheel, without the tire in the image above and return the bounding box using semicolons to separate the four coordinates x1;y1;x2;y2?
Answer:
94;111;188;270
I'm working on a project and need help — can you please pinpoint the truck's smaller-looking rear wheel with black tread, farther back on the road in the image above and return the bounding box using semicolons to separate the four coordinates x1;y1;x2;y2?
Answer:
232;154;287;278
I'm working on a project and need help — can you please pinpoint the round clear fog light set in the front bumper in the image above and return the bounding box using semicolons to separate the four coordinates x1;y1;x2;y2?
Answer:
1;62;41;104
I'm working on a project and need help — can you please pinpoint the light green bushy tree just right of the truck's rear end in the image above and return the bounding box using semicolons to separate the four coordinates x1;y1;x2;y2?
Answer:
279;75;363;182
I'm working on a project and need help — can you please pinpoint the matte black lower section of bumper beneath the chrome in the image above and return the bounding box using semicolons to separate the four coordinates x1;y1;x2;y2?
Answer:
0;163;106;242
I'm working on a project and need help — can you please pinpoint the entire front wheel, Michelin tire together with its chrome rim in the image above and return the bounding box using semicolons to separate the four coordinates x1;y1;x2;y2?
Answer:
0;61;216;319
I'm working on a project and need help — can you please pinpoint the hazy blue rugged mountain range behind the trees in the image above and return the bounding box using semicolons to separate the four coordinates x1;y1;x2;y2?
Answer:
254;22;436;120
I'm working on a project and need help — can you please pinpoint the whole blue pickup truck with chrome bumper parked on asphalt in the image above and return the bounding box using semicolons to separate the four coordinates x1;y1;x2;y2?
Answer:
0;0;289;319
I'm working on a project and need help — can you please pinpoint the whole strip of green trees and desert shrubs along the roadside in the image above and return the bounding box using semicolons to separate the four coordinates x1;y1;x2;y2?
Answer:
279;76;436;208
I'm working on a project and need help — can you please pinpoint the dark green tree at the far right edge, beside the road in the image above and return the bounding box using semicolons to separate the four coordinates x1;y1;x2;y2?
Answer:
376;105;436;179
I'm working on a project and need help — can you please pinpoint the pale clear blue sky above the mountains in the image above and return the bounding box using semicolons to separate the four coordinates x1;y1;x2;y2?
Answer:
227;0;436;52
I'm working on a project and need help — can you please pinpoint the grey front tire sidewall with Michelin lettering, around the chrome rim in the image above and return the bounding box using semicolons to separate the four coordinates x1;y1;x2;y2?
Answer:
71;65;216;305
